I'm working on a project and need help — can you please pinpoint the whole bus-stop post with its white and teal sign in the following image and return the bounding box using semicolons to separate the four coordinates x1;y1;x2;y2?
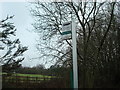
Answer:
62;21;78;89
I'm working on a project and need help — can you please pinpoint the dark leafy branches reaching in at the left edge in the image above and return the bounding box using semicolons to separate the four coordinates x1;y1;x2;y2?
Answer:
0;16;27;72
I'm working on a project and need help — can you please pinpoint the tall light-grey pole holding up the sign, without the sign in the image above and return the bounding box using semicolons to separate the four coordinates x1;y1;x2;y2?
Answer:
72;20;78;88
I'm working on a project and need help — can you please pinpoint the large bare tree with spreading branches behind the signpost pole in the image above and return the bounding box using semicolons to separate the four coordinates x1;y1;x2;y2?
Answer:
31;1;117;87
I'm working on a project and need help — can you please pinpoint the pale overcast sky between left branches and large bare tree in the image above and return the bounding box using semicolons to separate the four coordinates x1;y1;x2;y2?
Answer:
0;2;46;66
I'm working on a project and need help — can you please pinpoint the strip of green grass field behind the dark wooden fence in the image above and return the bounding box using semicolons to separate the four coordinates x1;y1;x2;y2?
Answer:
2;73;56;85
